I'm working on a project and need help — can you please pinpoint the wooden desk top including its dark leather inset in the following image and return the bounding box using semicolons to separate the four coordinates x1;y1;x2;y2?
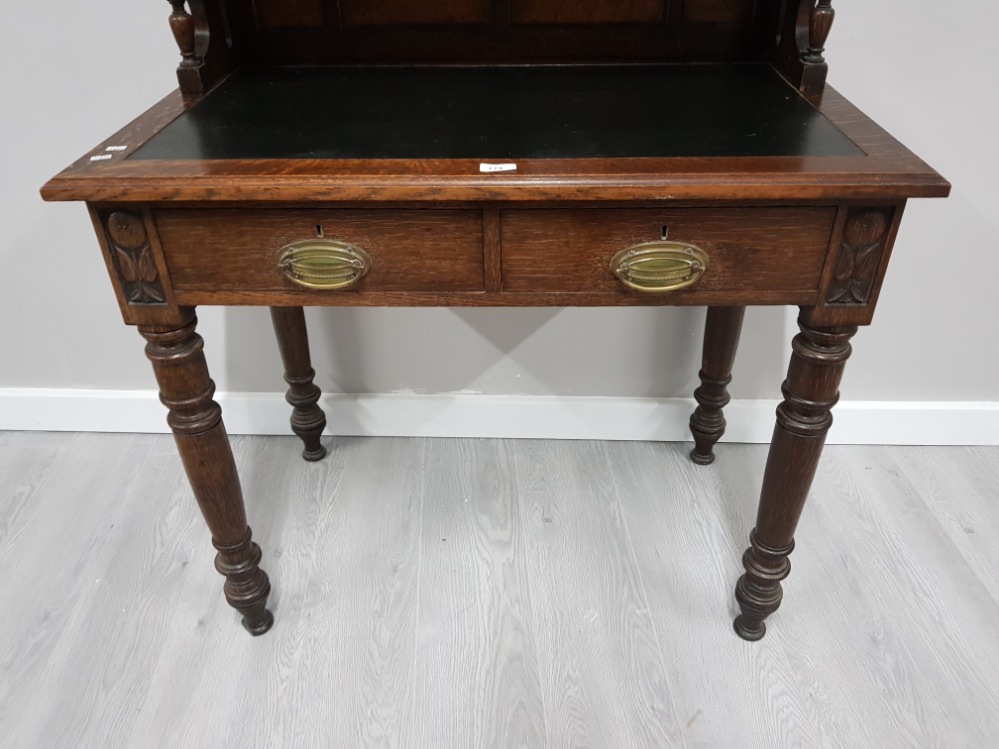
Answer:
43;64;949;203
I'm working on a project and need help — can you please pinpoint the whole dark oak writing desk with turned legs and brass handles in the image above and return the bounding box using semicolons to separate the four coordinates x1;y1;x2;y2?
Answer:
43;0;949;639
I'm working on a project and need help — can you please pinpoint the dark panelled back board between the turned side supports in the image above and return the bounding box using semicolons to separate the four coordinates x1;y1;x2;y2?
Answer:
225;0;781;64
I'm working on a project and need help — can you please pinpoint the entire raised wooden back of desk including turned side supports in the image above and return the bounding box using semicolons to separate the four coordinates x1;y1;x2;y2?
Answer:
170;0;832;97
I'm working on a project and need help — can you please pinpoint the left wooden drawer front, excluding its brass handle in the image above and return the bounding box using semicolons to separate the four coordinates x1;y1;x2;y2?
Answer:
153;208;484;294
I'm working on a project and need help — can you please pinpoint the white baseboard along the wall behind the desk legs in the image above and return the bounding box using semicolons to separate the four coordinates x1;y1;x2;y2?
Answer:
0;388;999;445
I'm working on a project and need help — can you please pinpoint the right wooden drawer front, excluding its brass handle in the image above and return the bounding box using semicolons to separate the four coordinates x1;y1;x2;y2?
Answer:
501;207;836;295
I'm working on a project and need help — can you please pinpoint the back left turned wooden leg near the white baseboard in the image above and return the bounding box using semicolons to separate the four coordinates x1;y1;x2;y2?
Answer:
271;307;326;461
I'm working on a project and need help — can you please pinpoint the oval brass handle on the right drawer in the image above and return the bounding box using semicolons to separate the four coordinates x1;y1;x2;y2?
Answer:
611;242;710;293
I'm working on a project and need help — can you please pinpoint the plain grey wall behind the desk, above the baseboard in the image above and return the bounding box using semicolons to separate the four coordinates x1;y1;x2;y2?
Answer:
0;0;999;410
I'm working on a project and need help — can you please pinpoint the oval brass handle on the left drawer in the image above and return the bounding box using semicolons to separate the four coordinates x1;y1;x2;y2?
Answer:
278;239;371;291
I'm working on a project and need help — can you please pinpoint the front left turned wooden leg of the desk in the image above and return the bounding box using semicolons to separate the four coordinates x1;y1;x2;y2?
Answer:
139;309;274;635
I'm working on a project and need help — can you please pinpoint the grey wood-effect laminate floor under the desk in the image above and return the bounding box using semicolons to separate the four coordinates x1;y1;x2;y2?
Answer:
0;433;999;749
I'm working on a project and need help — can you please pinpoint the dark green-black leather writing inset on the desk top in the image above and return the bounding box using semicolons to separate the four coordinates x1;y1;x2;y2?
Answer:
130;65;863;160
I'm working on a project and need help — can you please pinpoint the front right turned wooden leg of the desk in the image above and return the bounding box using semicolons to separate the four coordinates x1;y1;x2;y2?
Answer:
735;310;857;640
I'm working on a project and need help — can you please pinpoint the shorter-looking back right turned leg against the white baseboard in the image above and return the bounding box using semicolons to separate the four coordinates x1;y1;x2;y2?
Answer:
690;307;746;466
